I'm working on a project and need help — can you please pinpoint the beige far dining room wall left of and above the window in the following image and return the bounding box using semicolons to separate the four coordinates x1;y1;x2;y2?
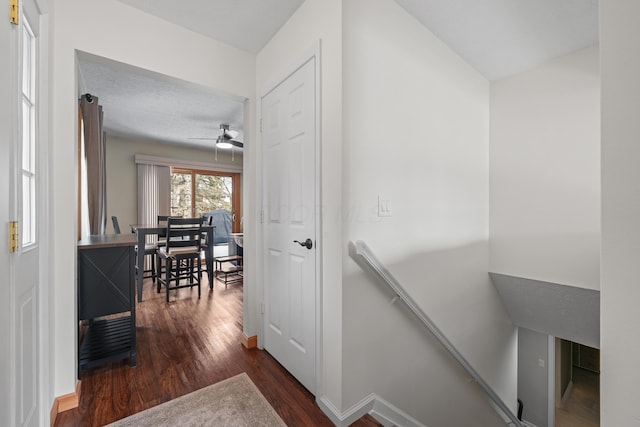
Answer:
107;136;242;233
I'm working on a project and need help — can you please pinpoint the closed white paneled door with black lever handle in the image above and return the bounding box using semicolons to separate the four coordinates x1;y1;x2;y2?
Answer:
262;58;317;394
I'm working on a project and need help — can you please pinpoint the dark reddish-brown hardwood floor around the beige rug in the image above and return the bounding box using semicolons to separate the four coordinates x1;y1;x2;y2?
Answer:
55;279;380;427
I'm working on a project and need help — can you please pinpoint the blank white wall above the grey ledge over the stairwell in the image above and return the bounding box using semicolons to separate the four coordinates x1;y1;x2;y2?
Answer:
490;46;600;289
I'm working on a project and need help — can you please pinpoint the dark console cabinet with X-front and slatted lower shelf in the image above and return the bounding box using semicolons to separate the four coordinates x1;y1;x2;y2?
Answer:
78;234;136;376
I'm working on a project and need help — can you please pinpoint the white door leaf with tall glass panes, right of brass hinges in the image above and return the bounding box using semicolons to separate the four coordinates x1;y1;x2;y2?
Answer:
10;0;43;427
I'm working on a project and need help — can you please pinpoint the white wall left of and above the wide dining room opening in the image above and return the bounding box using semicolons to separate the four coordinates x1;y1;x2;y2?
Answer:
49;0;255;396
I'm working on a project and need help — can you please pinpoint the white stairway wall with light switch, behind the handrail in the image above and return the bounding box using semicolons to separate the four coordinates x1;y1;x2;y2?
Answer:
342;0;517;426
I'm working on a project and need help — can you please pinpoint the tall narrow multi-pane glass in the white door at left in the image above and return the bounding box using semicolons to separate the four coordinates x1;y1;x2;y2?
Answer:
21;16;37;247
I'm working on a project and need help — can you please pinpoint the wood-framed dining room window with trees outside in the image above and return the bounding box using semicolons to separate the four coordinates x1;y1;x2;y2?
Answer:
171;168;241;231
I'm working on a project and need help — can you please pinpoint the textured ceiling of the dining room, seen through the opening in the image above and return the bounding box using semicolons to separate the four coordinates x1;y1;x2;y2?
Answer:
78;52;244;150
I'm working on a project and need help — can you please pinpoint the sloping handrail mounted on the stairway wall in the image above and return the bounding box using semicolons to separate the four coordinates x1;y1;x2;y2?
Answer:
355;240;524;427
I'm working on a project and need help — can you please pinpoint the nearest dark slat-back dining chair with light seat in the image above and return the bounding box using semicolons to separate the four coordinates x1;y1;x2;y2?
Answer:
157;217;202;302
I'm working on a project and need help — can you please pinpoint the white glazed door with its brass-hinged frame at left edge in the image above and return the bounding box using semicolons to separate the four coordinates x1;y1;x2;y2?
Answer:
0;0;42;426
